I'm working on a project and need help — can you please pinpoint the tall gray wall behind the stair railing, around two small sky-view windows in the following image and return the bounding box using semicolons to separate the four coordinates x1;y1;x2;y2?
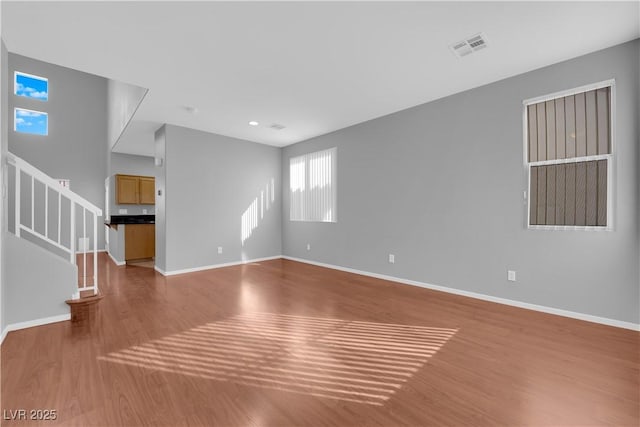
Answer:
8;54;108;248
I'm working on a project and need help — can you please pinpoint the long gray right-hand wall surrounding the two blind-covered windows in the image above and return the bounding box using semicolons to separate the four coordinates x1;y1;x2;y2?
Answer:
282;40;640;324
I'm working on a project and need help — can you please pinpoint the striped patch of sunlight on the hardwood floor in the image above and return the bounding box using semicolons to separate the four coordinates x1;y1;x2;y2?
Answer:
98;313;457;406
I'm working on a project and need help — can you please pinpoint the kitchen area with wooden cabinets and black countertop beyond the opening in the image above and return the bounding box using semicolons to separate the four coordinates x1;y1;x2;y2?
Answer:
105;153;155;266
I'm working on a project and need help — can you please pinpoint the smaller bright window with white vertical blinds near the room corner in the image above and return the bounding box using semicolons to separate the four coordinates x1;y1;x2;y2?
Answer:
289;147;337;222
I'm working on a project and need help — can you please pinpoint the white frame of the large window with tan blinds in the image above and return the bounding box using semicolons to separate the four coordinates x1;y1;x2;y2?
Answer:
522;79;616;231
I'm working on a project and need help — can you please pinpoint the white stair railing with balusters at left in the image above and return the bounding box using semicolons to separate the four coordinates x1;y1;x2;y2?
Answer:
8;153;102;299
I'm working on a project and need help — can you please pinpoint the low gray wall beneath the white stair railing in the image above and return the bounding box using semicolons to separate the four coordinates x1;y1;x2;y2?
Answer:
5;234;78;324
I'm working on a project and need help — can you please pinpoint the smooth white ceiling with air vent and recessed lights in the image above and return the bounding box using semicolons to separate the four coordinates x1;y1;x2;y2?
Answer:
1;1;640;154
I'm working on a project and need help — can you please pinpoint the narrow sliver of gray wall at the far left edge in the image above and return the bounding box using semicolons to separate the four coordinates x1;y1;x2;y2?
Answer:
0;39;9;335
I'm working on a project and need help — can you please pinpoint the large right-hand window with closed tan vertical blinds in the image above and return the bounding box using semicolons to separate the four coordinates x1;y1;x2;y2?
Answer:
524;81;614;229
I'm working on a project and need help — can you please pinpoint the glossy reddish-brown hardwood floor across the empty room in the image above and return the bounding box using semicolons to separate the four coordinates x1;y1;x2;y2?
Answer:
1;254;640;426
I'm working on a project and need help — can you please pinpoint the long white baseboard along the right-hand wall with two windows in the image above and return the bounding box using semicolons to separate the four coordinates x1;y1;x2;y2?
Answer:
282;255;640;331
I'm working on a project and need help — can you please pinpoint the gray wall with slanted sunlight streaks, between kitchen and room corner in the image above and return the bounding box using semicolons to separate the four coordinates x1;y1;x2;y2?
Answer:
162;125;282;272
